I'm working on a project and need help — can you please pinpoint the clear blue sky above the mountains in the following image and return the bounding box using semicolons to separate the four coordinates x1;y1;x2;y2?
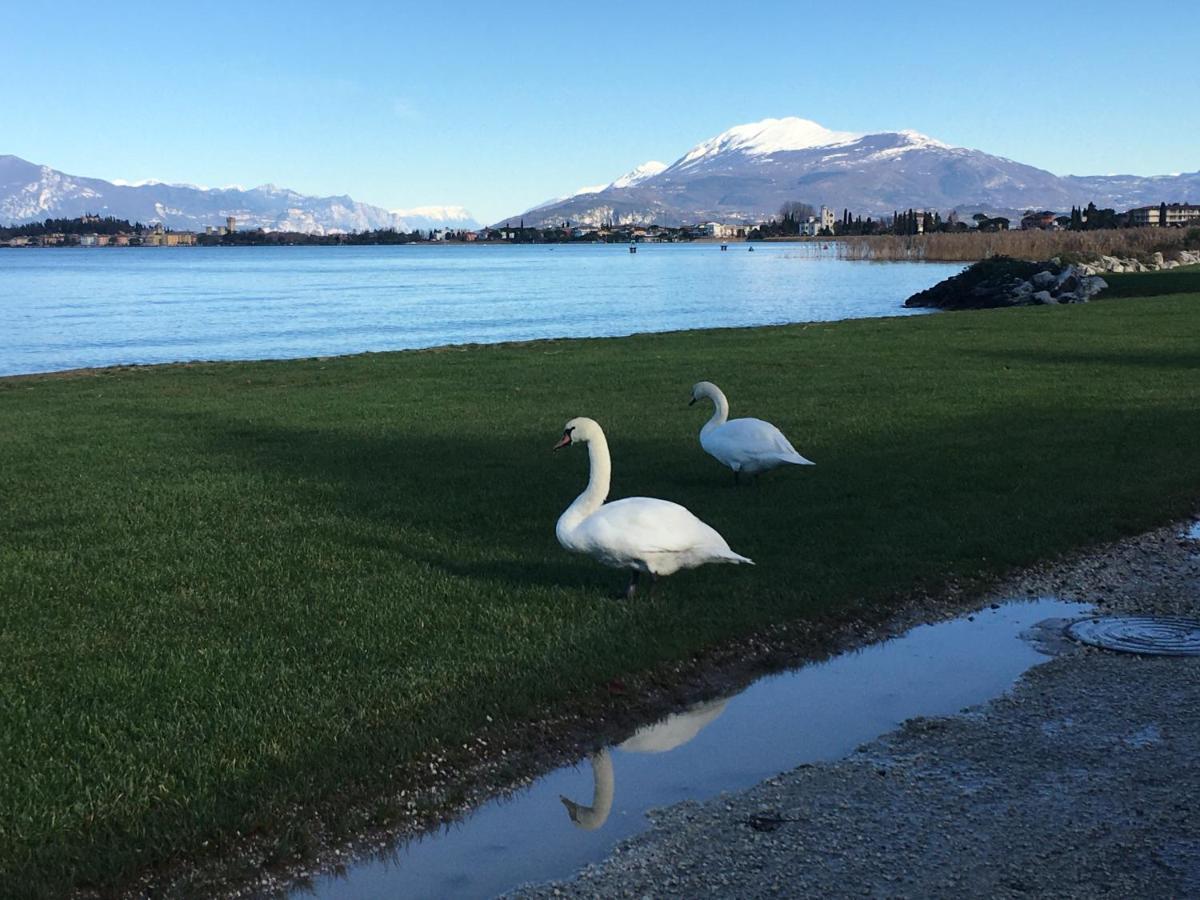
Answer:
0;0;1200;221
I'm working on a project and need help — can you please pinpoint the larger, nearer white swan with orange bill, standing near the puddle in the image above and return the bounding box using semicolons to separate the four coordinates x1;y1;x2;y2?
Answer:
554;416;754;599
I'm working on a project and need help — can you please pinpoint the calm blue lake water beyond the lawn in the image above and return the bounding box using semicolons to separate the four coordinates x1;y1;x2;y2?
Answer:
0;244;961;374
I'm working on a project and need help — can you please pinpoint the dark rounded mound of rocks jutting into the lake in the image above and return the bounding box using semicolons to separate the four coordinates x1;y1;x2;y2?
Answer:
904;257;1108;310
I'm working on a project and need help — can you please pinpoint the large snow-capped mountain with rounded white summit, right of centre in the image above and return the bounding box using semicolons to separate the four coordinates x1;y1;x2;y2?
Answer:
524;118;1200;226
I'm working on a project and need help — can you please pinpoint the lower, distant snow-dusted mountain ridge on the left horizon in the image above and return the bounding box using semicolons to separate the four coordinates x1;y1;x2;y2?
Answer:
0;156;479;234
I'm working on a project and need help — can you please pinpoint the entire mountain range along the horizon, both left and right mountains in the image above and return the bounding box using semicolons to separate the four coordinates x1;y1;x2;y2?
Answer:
7;118;1200;234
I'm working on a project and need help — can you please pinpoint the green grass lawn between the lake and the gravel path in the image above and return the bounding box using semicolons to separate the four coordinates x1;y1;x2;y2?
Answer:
0;270;1200;894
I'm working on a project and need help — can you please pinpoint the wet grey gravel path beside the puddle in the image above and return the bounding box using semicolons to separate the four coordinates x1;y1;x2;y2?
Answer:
518;526;1200;898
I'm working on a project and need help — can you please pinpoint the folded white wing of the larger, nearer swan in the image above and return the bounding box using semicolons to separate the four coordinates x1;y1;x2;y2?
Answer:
577;497;732;557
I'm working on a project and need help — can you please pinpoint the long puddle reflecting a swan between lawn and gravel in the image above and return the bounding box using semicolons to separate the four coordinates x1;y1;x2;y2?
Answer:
293;599;1092;900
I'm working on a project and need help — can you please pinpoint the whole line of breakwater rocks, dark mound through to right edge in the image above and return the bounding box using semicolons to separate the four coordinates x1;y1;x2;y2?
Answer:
904;250;1200;310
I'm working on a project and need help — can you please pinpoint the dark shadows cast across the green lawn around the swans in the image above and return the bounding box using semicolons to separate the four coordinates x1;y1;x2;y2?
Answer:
157;386;1196;608
